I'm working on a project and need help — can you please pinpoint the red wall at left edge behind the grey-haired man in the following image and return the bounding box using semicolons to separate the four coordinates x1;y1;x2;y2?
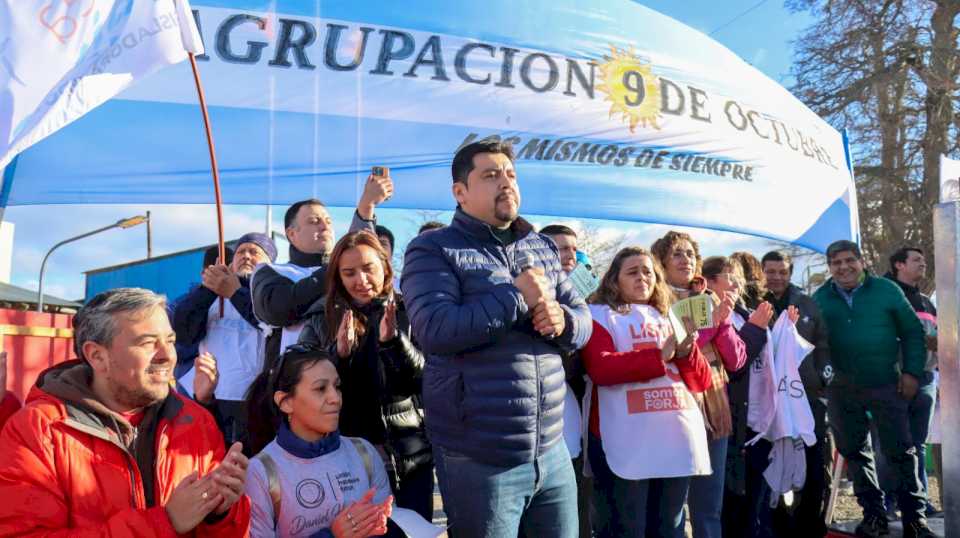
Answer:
0;308;74;402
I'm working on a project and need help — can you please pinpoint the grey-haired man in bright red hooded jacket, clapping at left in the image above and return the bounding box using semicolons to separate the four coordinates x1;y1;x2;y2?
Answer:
0;288;250;538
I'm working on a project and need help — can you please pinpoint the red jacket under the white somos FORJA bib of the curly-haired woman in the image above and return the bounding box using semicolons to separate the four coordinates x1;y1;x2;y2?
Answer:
580;321;712;437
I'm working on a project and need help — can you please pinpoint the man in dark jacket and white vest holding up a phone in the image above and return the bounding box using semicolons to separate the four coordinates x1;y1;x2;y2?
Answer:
250;174;393;368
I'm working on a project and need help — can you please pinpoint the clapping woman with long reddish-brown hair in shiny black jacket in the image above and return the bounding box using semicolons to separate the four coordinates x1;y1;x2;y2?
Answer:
300;231;433;521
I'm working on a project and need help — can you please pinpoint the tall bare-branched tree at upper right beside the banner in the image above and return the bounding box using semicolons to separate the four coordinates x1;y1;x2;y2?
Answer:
787;0;960;287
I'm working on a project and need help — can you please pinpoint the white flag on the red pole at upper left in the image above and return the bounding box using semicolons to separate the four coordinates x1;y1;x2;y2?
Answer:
0;0;202;170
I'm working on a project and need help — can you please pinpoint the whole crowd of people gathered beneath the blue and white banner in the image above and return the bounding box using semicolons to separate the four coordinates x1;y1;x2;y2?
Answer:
0;141;936;538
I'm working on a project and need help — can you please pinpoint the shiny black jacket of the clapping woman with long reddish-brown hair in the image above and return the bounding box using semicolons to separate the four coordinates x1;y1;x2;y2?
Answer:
300;301;433;478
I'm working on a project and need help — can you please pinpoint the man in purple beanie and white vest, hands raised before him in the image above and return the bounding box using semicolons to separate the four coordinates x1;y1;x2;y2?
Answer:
173;232;277;443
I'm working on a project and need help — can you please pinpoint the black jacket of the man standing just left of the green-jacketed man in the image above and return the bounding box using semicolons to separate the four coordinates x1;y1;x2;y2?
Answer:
767;284;833;400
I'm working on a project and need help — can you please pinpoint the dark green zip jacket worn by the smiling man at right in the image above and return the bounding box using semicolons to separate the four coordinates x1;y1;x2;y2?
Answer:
813;273;926;387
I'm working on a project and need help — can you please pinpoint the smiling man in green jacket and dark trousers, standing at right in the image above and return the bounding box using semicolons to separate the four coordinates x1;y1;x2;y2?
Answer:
813;241;934;538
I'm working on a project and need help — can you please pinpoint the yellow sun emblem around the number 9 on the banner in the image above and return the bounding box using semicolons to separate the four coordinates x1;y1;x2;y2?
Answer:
598;45;661;133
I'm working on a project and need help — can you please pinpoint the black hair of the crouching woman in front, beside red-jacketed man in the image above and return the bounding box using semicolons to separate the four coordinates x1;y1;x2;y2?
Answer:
245;344;336;456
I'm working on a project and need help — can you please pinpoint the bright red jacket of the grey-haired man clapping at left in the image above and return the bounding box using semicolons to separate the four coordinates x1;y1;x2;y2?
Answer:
0;361;250;538
